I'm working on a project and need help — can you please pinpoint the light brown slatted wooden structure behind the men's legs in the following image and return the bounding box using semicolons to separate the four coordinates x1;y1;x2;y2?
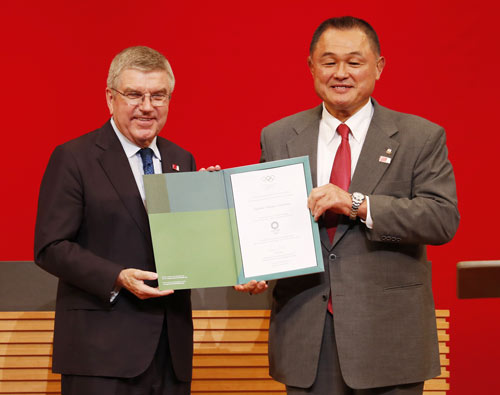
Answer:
0;310;450;395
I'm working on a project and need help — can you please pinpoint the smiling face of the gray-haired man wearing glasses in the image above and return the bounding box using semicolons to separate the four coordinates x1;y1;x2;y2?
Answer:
106;69;170;148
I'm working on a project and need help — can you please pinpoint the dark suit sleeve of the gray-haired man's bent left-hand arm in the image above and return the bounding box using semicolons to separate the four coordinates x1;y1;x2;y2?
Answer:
35;146;123;302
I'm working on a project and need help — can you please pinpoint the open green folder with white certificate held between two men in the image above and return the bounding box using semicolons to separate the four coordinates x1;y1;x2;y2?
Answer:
144;157;324;289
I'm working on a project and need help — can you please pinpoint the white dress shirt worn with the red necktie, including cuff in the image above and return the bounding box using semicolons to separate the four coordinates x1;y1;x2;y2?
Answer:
316;100;374;229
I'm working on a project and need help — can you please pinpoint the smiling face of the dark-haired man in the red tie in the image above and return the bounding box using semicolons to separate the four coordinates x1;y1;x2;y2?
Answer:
308;28;385;122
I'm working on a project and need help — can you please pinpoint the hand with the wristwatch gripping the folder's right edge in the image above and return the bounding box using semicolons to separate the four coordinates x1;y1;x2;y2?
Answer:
307;184;352;221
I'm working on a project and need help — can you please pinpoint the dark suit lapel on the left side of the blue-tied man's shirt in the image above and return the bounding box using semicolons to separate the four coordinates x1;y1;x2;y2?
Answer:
96;122;151;241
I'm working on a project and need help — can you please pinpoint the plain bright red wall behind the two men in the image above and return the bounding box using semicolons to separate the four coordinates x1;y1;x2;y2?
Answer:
0;0;500;395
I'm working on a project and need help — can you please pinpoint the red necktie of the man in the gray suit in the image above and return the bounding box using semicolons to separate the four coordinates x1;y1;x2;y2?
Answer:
325;123;351;314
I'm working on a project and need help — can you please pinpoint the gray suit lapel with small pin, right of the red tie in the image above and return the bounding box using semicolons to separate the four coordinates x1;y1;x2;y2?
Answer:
332;99;399;247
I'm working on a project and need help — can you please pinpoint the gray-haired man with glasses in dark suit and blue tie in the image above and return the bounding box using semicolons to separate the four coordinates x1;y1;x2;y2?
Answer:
35;47;196;395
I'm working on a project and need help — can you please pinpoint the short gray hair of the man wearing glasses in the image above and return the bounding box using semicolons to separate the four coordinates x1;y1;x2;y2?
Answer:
107;46;175;94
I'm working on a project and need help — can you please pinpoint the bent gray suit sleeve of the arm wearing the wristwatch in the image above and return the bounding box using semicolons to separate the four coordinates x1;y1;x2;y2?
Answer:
367;128;460;245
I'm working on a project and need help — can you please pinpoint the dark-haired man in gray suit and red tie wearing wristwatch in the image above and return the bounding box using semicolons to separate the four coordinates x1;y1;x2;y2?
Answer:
236;17;459;395
